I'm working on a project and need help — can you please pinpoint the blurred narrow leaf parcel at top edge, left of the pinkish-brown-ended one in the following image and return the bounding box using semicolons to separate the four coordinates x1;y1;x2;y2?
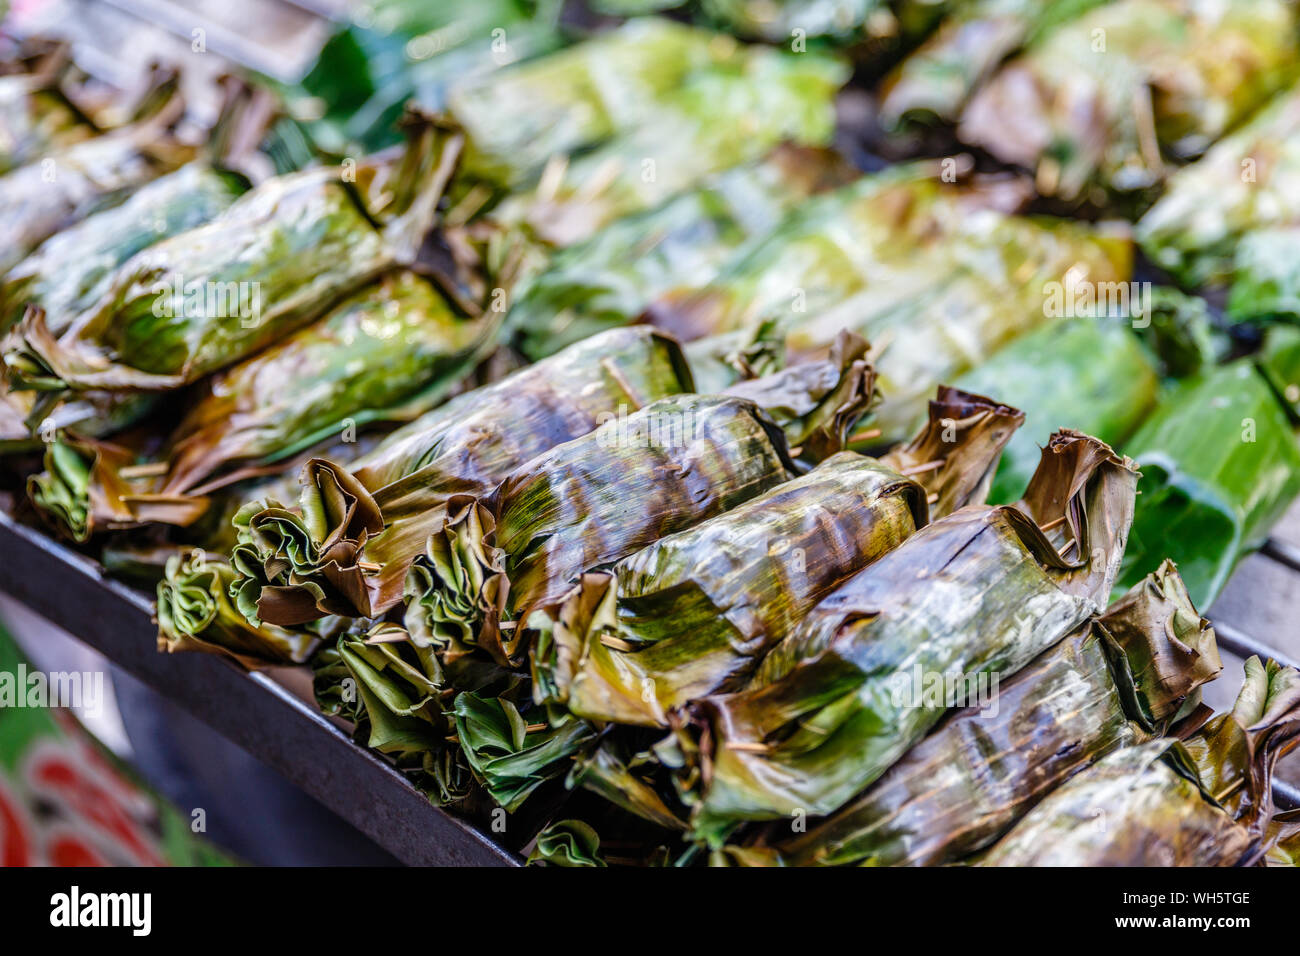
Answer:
880;0;1101;129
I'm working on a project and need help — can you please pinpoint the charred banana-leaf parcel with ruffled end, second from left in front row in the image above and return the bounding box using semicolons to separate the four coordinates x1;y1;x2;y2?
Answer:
406;385;865;666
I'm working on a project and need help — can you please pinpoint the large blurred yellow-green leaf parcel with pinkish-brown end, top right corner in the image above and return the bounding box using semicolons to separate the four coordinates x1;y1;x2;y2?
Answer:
958;0;1296;200
